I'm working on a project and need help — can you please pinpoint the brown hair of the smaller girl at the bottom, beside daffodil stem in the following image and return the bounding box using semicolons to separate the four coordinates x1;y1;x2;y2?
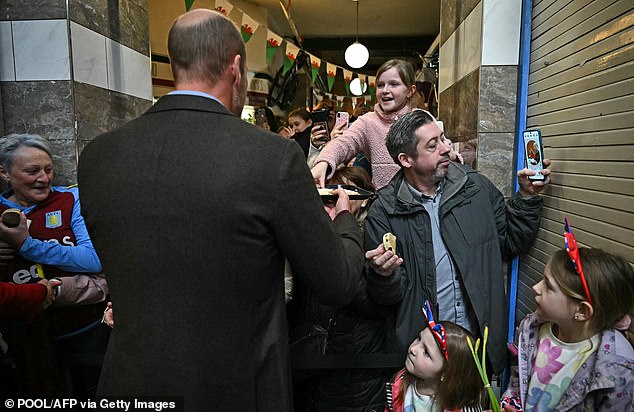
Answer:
395;321;484;410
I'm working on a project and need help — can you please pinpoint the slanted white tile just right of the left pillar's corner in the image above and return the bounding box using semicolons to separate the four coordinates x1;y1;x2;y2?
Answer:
70;22;108;89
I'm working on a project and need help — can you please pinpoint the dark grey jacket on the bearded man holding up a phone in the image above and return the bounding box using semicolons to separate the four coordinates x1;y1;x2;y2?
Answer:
365;163;542;373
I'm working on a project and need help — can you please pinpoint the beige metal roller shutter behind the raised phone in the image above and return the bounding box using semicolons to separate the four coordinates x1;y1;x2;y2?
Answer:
516;0;634;323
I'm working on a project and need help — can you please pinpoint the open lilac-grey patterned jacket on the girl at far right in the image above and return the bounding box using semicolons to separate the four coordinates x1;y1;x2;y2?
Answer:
502;313;634;412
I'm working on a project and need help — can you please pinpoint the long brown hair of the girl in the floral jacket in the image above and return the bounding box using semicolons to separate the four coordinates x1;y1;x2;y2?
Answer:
548;248;634;340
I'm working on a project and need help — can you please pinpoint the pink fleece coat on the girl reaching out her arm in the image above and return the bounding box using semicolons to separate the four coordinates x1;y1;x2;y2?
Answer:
315;104;412;189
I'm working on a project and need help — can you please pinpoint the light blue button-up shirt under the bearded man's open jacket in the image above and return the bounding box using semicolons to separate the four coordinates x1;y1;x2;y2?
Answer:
407;183;478;334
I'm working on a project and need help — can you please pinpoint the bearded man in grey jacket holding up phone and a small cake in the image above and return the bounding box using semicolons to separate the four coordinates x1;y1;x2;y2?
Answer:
365;110;550;373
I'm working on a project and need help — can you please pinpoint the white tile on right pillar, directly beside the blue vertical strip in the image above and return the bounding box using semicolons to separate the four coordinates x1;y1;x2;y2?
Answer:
482;0;522;66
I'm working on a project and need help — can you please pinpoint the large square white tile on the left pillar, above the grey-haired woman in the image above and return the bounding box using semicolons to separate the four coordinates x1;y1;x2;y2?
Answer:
12;20;70;81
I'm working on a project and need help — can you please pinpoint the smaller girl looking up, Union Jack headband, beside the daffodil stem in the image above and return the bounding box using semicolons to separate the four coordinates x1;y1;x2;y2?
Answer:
385;301;483;412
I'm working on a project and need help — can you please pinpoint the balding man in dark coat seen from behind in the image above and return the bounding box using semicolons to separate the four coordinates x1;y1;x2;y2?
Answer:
78;9;363;411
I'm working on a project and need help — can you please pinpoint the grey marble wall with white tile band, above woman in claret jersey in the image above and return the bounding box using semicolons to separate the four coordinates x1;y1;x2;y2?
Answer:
0;0;152;184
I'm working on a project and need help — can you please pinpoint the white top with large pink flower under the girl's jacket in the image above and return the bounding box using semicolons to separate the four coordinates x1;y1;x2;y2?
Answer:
526;323;599;412
